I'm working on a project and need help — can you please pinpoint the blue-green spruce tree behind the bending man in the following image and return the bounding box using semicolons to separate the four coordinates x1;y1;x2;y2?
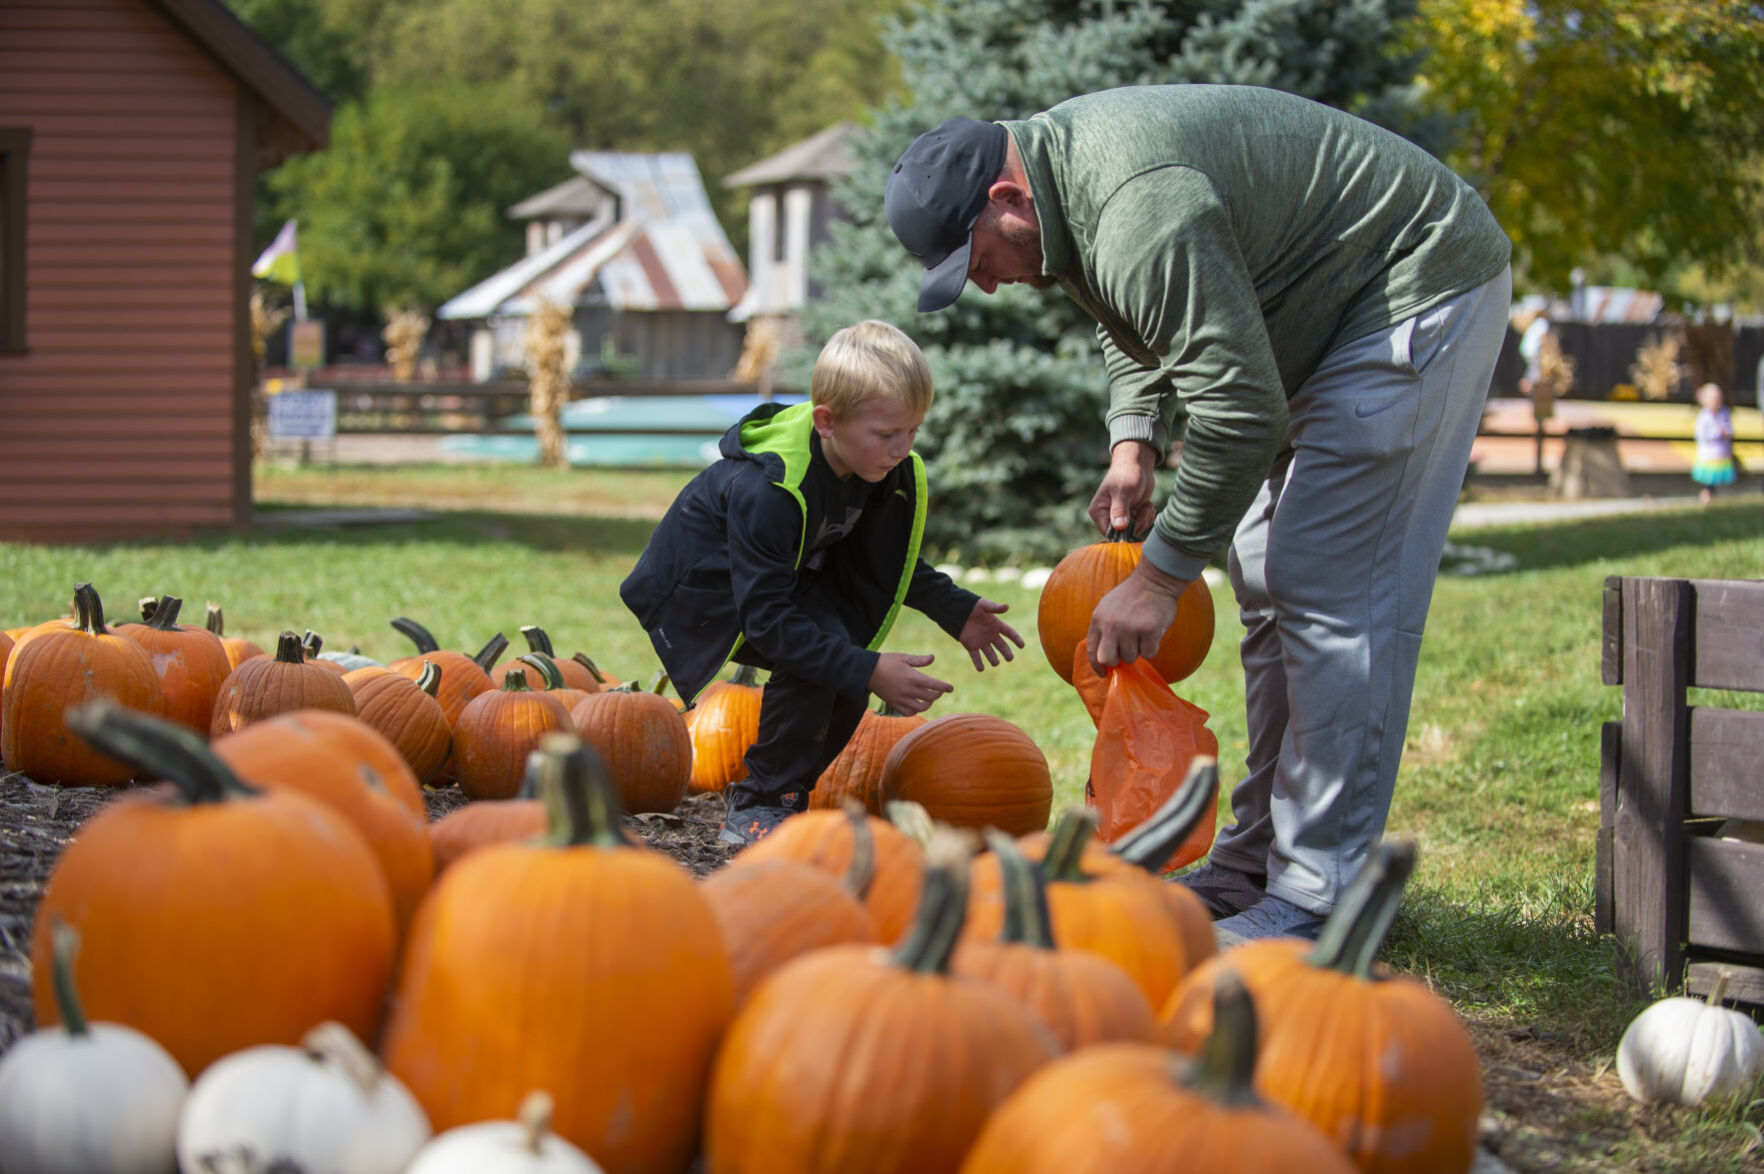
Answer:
796;0;1429;562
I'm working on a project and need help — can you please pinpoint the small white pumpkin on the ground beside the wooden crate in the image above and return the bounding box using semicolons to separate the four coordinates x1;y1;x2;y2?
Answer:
1618;971;1764;1105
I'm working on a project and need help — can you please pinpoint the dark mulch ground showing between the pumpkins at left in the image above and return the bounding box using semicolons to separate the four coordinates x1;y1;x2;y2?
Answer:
0;767;734;1052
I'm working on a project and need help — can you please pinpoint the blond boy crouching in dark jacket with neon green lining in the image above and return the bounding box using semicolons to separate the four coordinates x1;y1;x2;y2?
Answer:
619;321;1023;844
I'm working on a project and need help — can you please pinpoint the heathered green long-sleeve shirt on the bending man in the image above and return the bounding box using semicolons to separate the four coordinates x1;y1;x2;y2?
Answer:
1002;85;1510;578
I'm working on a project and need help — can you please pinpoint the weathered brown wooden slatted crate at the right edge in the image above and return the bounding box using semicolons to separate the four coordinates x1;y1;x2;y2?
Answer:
1595;576;1764;1003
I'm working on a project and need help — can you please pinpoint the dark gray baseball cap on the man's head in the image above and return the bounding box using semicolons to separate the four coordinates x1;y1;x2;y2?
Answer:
882;118;1011;314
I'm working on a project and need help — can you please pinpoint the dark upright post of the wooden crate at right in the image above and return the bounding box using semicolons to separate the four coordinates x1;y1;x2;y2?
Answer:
1612;578;1693;991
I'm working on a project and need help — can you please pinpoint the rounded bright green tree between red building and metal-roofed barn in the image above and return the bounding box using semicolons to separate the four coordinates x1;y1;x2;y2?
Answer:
270;83;572;312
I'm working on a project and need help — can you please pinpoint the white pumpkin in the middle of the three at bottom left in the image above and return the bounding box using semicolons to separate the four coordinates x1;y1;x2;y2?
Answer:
178;1022;432;1174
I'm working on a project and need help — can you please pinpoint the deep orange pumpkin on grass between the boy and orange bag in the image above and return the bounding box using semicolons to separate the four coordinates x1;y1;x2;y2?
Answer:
882;714;1053;836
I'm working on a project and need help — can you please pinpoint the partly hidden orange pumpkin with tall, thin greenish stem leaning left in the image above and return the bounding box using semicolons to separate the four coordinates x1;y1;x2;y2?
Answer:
951;830;1157;1051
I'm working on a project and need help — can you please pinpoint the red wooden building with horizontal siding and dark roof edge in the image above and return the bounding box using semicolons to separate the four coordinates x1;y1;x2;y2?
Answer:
0;0;330;541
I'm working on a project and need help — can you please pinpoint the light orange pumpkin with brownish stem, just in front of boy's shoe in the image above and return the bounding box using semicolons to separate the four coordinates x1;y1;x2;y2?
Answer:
725;811;924;945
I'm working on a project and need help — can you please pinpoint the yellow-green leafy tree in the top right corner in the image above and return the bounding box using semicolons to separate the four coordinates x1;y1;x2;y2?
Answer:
1413;0;1764;291
